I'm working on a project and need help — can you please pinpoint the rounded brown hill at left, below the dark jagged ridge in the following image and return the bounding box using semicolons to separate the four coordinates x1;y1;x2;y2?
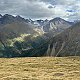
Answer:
0;21;43;47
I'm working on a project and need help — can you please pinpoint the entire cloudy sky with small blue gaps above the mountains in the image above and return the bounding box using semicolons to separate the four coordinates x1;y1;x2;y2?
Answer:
0;0;80;21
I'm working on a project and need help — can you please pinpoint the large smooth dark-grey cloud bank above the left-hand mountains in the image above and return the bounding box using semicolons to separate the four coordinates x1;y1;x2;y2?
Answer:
0;0;54;18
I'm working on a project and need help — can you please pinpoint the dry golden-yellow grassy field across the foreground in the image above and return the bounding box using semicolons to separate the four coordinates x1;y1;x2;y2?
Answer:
0;57;80;80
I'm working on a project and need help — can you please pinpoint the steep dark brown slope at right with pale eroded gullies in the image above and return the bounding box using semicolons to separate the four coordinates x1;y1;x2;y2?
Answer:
46;22;80;56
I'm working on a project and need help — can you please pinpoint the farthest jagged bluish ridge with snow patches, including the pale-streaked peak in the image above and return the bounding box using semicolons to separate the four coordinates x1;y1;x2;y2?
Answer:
0;14;74;38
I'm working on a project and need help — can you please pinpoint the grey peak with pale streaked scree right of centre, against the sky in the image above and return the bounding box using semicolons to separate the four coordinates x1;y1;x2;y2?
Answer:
43;17;74;38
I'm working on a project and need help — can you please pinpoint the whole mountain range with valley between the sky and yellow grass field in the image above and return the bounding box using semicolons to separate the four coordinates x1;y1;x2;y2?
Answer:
0;14;80;57
